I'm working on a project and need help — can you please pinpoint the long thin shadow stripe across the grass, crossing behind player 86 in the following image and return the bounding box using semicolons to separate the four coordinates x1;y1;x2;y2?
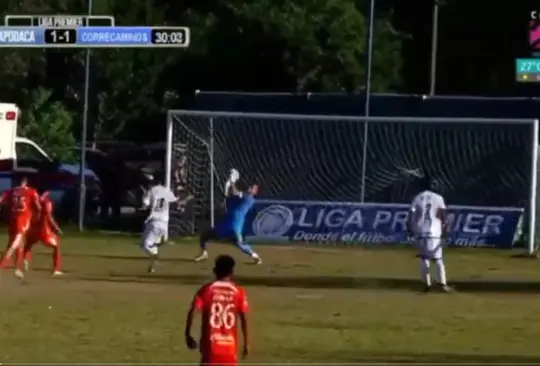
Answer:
71;273;540;293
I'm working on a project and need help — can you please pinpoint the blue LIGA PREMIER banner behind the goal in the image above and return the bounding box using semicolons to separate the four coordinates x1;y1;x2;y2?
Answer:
244;200;523;248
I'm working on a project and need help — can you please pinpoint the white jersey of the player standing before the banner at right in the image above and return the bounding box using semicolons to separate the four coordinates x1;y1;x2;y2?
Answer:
410;191;446;238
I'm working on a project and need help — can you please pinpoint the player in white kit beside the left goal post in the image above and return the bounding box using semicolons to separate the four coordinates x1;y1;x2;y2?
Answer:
142;176;191;273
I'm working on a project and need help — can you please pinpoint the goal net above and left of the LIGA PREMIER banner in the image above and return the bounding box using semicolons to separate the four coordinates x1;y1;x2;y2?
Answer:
168;111;538;250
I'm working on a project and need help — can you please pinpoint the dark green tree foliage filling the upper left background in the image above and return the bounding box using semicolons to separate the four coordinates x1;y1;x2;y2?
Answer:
0;0;403;150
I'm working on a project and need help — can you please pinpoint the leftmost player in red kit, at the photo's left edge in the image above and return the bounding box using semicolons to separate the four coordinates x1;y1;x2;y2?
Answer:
0;177;41;277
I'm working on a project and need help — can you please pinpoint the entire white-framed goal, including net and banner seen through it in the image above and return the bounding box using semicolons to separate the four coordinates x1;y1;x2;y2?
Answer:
165;110;539;253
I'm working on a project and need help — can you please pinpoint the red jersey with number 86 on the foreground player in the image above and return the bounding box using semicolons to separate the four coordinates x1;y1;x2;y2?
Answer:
193;281;248;363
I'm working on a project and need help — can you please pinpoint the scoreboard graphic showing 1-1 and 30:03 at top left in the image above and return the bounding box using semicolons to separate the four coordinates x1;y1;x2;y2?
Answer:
0;15;190;48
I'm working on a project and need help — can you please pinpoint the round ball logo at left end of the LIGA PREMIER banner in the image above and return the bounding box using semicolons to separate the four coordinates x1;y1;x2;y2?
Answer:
252;205;294;238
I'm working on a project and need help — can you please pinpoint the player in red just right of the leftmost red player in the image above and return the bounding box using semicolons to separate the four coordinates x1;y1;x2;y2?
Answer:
23;192;62;276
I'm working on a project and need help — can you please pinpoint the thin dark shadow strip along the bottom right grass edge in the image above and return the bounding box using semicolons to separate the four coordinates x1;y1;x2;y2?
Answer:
329;351;540;364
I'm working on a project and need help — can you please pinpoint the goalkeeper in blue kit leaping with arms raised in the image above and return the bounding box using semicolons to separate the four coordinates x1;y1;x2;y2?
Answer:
195;184;262;264
